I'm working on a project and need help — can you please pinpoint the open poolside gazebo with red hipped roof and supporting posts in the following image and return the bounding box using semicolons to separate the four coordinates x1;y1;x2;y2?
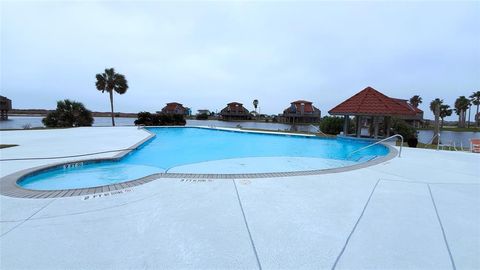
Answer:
328;86;423;139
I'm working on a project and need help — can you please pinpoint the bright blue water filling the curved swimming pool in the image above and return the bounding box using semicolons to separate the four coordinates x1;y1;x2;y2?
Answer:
18;127;388;190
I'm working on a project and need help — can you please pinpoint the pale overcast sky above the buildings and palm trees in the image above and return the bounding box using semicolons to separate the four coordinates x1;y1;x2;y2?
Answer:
0;1;480;120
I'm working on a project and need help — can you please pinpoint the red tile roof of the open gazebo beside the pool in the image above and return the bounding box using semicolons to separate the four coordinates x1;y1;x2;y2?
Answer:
328;86;417;115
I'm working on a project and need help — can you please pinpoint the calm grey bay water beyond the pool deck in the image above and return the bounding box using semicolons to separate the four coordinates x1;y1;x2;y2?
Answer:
0;116;480;147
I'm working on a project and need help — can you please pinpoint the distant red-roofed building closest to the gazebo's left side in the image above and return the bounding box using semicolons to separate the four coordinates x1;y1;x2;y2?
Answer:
279;100;321;124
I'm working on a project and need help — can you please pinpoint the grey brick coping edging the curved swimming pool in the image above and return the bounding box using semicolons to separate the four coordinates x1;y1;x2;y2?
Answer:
0;126;398;199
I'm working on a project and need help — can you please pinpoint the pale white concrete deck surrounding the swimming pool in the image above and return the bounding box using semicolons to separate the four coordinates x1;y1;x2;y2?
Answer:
0;127;480;269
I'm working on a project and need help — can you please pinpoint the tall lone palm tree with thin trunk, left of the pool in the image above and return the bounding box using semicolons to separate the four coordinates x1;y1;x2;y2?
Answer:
95;68;128;126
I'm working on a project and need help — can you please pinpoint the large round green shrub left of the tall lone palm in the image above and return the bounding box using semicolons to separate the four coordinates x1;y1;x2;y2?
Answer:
42;99;94;127
